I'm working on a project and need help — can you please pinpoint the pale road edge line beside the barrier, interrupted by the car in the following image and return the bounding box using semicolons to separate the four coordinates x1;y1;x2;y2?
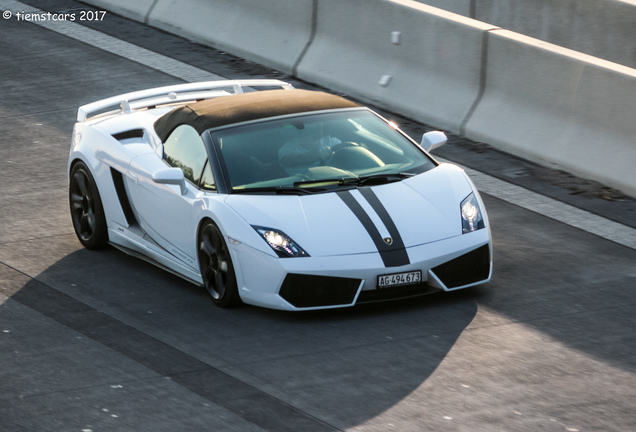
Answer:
0;0;636;250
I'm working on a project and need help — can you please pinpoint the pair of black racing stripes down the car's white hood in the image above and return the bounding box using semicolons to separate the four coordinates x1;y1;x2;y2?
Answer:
338;189;410;267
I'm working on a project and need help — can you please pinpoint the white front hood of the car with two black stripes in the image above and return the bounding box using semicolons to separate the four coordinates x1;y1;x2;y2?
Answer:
226;164;472;256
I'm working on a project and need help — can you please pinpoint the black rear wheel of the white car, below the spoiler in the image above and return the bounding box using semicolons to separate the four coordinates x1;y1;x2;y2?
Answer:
69;162;108;249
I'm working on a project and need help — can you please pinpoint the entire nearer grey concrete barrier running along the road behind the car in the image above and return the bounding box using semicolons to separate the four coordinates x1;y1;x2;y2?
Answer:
80;0;636;196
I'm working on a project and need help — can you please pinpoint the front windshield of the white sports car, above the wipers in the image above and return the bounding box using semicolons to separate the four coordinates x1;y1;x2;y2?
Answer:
211;109;435;193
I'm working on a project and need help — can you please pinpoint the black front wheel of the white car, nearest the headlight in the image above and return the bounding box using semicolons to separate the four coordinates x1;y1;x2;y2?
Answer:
198;220;241;308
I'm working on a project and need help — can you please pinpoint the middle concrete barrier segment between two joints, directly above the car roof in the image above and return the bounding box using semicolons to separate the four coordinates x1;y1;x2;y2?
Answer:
296;0;492;132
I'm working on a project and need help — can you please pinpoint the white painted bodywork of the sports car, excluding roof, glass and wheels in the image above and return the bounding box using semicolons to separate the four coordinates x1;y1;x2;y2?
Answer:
68;81;492;310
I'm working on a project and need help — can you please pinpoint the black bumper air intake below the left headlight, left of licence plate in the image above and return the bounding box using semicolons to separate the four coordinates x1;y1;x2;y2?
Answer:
279;273;362;308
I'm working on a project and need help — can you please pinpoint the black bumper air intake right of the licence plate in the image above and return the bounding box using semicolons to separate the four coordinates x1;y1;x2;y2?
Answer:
431;245;490;288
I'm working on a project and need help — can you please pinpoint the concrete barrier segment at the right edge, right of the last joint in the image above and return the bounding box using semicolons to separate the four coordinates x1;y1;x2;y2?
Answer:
465;30;636;196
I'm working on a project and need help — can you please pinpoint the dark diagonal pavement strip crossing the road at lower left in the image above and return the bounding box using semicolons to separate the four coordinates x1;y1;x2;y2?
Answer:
0;263;338;432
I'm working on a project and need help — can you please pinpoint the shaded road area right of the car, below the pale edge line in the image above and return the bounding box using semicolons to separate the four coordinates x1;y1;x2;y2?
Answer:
473;196;636;373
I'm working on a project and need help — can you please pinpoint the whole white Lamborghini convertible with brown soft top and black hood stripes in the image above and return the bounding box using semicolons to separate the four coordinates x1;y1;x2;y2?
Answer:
68;80;492;310
